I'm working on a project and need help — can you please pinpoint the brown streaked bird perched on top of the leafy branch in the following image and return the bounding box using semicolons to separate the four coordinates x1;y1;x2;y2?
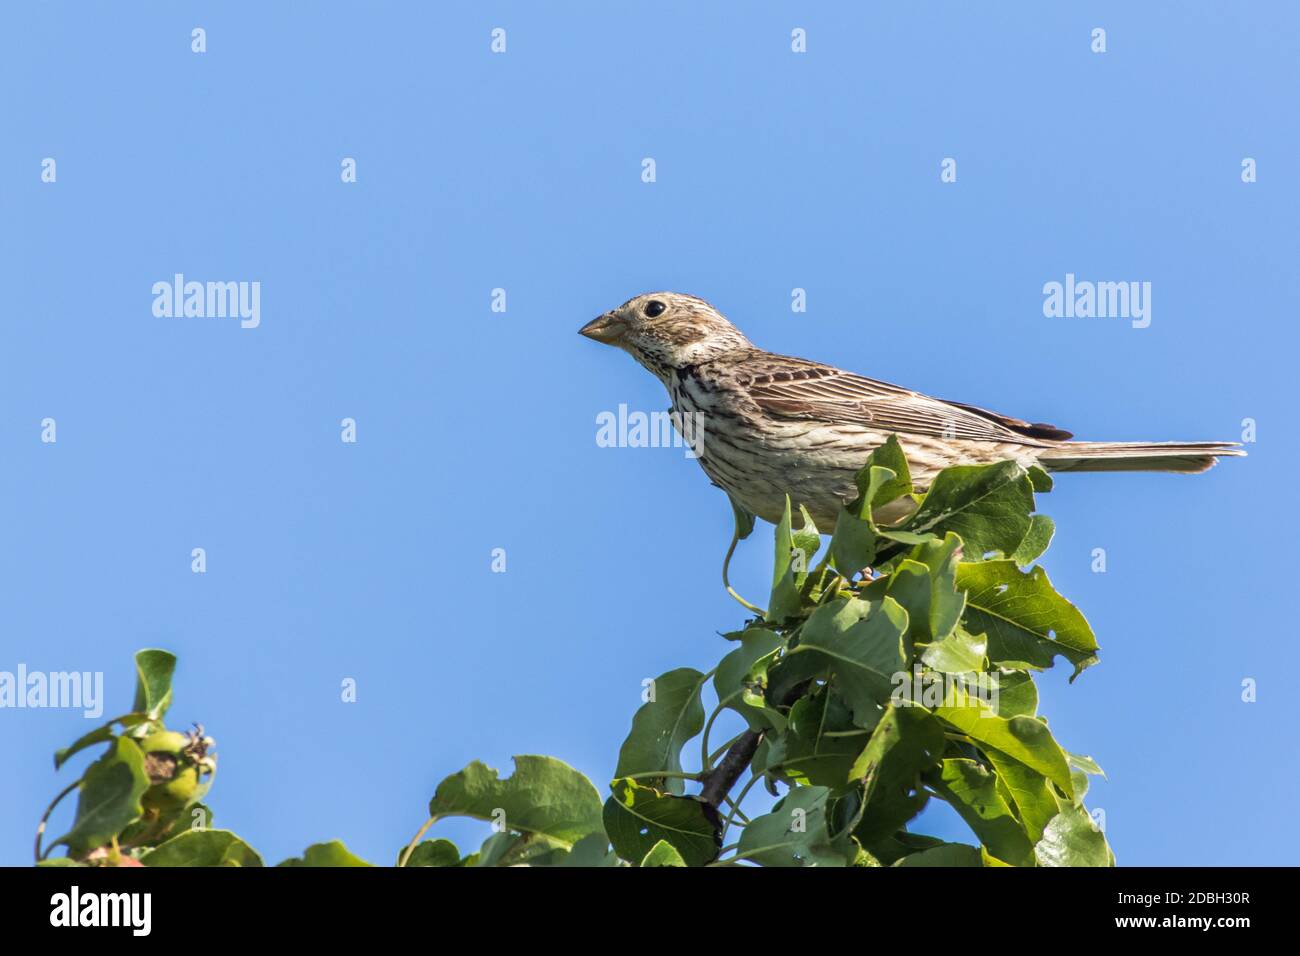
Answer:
579;291;1245;529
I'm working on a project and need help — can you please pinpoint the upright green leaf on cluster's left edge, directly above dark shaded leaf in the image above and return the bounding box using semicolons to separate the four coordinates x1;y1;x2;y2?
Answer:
614;667;707;793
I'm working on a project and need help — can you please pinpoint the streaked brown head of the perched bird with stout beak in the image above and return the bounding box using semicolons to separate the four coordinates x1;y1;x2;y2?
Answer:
579;293;750;378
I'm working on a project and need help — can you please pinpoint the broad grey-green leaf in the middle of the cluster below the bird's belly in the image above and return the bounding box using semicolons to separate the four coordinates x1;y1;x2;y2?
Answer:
768;597;907;727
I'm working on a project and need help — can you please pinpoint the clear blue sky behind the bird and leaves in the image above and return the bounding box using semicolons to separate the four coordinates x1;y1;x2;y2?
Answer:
0;0;1300;865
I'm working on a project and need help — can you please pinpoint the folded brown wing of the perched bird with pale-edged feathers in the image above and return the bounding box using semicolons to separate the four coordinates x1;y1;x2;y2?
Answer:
740;356;1071;445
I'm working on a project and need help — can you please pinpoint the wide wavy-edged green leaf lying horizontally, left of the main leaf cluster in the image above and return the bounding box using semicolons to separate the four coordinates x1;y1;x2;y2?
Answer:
429;754;601;845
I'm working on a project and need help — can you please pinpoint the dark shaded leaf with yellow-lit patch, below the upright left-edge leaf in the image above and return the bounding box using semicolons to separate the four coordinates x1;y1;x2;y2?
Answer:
603;778;722;866
